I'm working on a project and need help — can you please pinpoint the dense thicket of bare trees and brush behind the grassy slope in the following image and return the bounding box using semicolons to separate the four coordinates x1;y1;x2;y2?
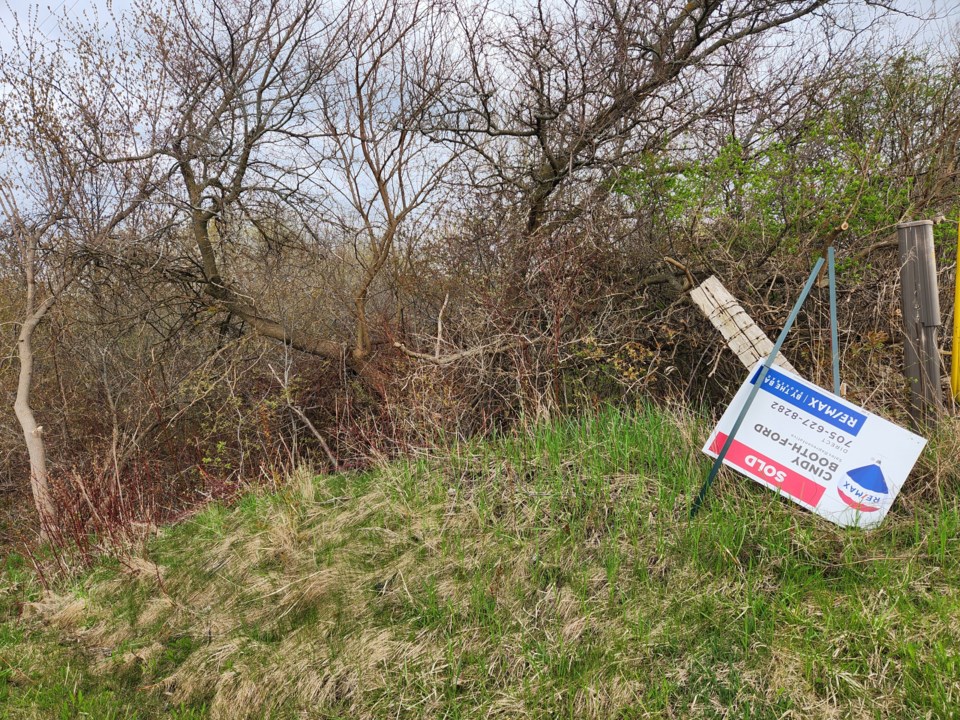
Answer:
0;0;960;532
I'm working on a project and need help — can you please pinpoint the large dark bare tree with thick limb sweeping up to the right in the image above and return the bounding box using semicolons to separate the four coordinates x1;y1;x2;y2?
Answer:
433;0;856;245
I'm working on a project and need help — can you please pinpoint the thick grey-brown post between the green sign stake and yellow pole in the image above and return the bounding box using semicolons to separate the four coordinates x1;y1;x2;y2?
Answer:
897;220;943;425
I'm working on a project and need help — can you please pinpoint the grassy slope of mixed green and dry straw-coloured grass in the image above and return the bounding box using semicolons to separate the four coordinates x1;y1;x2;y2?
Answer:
0;411;960;718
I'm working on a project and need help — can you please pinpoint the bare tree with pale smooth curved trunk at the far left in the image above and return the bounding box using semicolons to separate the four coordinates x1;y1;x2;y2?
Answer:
0;16;154;531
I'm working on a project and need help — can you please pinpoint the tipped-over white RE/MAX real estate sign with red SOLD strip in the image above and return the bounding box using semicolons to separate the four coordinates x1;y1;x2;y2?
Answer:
703;363;927;528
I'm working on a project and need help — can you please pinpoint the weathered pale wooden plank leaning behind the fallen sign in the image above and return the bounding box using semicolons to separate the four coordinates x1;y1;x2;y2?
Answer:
690;275;800;375
